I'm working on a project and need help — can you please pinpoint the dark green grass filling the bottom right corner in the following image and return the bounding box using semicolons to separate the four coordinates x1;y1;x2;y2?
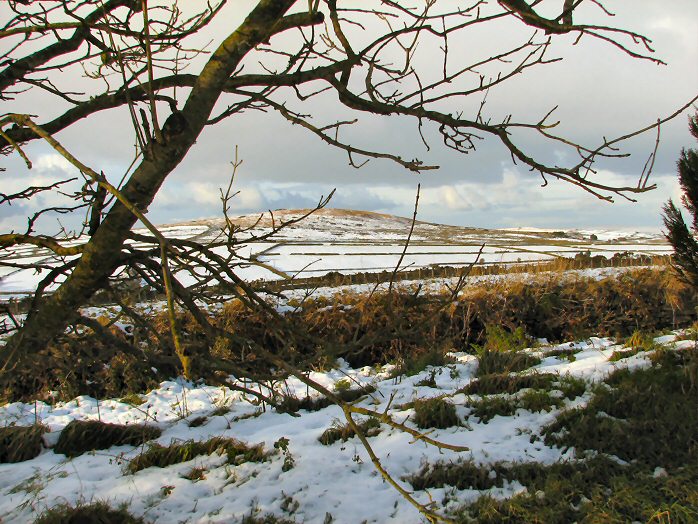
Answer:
406;455;698;524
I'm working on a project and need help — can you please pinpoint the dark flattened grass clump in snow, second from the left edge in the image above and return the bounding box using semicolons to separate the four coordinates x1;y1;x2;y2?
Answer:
53;420;161;457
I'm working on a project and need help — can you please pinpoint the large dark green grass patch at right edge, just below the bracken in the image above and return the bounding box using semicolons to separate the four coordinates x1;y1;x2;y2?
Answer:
543;349;698;467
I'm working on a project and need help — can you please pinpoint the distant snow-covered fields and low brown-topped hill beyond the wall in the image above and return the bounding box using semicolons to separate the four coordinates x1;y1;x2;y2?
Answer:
0;209;671;297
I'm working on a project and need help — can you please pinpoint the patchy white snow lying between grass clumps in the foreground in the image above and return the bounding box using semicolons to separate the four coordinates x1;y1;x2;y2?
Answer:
0;336;694;524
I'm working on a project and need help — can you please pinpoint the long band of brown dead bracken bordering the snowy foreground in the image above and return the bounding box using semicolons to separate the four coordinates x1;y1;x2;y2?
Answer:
2;268;698;402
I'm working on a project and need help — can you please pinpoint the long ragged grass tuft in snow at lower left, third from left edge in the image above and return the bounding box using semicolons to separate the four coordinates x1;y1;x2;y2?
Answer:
127;437;267;473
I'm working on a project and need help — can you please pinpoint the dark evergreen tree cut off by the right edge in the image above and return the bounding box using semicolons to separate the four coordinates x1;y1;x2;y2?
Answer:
664;112;698;288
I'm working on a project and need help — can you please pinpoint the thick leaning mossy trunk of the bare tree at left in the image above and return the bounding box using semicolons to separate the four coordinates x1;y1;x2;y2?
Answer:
0;0;295;372
